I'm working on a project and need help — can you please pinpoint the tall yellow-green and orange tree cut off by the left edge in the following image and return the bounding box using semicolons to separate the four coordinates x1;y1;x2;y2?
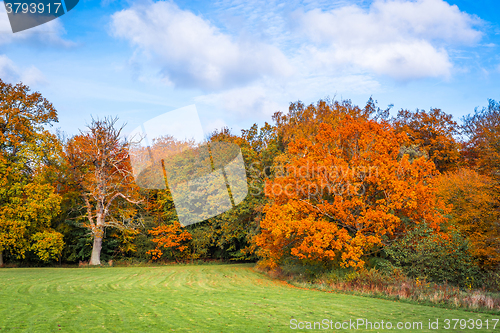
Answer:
0;80;62;266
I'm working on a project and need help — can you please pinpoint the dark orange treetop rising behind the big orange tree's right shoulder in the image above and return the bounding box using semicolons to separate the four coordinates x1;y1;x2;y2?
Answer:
393;109;460;172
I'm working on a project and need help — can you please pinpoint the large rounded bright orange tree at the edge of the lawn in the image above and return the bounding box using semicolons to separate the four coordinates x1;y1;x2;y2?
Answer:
255;113;447;268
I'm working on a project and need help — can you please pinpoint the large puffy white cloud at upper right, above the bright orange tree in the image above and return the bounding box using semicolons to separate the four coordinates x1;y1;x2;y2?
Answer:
294;0;481;81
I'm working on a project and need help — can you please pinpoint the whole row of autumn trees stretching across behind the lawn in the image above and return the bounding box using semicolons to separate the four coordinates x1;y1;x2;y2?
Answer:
0;81;500;286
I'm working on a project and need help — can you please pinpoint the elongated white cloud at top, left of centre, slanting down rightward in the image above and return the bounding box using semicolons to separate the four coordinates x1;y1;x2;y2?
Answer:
112;2;291;90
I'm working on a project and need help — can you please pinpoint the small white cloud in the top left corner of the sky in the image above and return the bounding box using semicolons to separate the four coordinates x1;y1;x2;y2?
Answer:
0;4;75;47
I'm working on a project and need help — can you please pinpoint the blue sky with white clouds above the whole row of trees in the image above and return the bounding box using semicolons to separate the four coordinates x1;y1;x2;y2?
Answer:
0;0;500;135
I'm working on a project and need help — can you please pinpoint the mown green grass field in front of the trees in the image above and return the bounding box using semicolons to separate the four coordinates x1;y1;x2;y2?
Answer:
0;265;500;333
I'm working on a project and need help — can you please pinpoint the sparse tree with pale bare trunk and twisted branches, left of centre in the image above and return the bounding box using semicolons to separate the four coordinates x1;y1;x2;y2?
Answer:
65;118;141;265
